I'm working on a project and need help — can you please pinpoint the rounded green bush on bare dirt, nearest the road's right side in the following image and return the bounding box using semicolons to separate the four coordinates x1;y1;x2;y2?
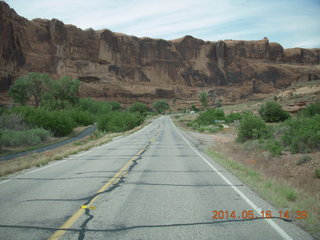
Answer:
237;113;269;142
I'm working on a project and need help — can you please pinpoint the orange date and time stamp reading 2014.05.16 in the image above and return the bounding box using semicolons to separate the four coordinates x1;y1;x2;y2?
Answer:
211;210;308;220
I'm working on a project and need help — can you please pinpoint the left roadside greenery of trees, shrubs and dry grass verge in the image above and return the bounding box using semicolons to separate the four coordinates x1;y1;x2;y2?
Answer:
0;73;169;176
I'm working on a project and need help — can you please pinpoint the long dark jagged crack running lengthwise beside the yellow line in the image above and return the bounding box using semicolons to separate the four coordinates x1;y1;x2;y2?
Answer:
78;133;159;240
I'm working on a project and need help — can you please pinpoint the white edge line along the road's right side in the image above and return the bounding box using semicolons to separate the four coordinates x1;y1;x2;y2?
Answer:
169;118;293;240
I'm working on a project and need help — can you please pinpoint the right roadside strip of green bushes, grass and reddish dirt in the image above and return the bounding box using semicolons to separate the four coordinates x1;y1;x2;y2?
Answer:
177;101;320;239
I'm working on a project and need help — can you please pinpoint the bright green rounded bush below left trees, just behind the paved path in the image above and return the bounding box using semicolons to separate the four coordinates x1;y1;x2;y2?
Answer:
26;108;76;137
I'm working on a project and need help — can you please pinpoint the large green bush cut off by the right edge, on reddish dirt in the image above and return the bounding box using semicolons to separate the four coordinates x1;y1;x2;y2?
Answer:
281;115;320;153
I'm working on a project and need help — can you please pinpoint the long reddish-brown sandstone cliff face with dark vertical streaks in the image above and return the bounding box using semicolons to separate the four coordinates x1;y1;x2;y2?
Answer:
0;2;320;103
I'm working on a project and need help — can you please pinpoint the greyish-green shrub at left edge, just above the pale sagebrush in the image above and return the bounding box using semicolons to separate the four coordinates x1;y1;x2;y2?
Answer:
0;112;28;130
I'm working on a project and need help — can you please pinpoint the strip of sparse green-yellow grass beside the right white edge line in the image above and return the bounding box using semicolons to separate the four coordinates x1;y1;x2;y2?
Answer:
207;149;320;235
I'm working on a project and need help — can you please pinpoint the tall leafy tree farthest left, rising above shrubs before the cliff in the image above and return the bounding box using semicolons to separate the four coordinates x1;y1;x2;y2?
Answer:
9;72;51;107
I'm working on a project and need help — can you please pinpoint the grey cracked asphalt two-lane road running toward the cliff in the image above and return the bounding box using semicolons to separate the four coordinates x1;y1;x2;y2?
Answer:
0;116;311;240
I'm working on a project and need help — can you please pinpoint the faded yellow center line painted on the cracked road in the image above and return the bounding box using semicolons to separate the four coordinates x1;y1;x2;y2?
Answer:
48;146;147;240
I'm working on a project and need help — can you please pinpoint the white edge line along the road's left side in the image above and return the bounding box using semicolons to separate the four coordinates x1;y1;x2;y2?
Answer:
0;120;155;185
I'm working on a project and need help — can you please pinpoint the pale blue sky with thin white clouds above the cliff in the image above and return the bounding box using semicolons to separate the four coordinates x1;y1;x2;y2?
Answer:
5;0;320;48
